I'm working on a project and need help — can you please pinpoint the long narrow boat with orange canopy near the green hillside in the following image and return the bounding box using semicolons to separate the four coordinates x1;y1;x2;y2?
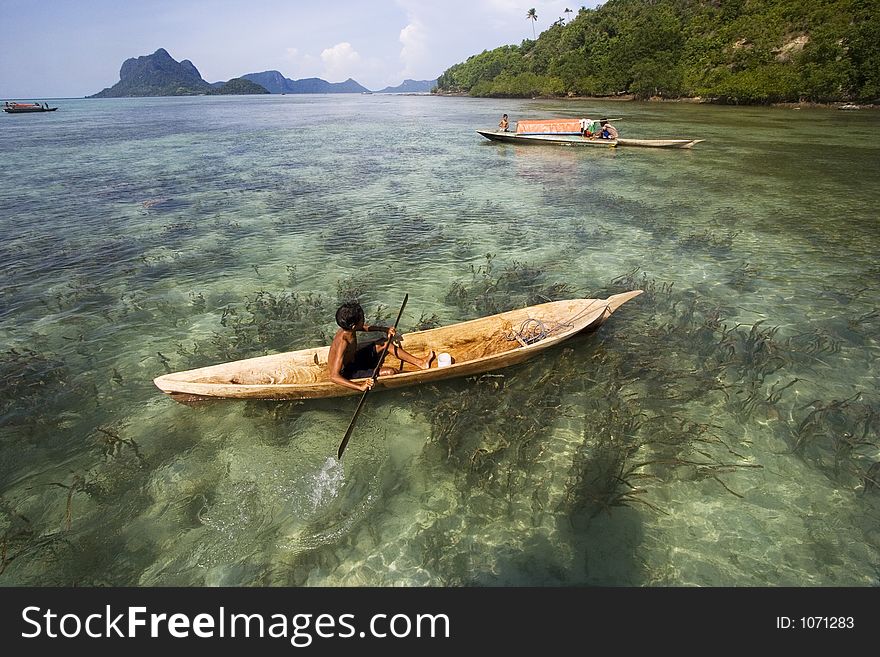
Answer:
477;119;704;148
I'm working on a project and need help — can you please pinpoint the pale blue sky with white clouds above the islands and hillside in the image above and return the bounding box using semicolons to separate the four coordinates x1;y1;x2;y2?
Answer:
0;0;599;100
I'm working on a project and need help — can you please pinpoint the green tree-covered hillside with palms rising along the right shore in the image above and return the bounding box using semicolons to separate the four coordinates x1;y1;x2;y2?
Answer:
437;0;880;103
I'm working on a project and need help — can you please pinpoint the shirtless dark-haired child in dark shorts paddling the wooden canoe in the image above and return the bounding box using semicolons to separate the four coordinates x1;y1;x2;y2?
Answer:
327;301;436;392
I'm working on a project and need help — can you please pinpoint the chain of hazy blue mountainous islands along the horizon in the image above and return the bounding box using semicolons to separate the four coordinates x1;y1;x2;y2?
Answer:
87;48;437;98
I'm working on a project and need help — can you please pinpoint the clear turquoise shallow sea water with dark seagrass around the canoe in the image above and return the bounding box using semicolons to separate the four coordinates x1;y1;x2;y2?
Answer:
0;94;880;587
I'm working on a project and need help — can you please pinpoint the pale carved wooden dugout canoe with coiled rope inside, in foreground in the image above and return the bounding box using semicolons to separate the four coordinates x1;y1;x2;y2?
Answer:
154;290;642;401
